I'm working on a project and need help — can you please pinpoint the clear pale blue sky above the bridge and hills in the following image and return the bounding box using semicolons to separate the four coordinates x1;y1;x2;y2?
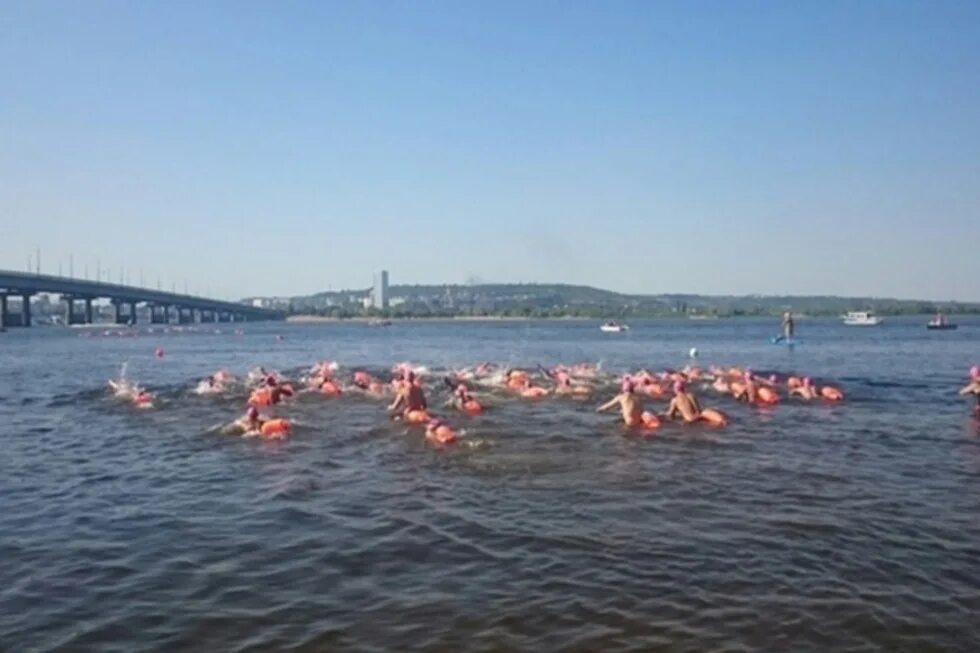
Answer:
0;0;980;301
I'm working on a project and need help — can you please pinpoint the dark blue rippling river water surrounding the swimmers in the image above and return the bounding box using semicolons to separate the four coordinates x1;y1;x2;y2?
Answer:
0;321;980;652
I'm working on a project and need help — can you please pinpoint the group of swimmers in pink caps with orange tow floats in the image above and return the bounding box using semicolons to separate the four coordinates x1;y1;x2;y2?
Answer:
110;361;980;445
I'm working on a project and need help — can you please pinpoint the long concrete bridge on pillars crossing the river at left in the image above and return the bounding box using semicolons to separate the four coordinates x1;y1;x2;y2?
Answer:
0;270;284;327
